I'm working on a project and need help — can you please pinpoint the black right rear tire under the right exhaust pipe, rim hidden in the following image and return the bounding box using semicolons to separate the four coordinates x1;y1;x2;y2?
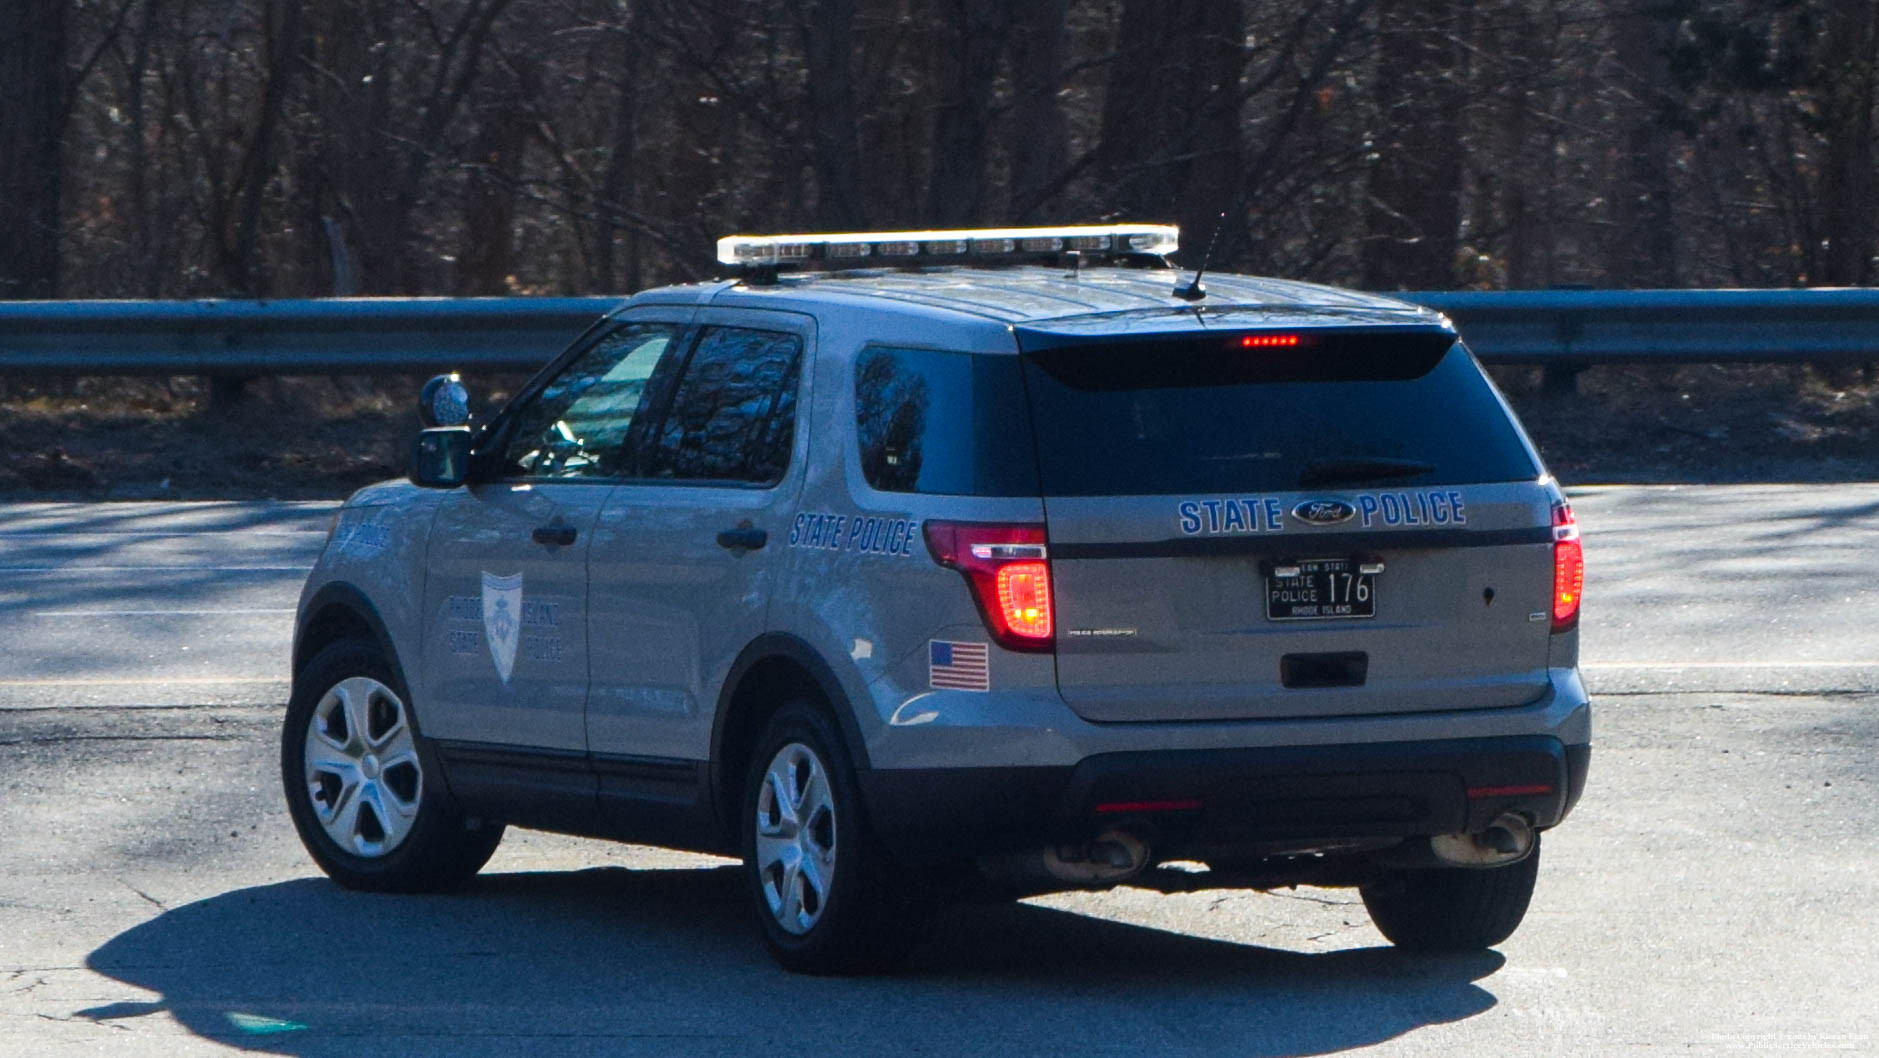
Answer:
1360;834;1539;951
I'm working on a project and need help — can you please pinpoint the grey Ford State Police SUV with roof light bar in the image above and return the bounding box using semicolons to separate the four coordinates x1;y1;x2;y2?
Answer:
282;226;1590;973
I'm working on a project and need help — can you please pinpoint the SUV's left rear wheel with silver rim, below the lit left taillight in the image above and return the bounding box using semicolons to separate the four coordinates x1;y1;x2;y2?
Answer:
742;701;923;975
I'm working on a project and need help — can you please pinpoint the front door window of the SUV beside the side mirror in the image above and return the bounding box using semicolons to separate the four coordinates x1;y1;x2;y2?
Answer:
502;323;680;479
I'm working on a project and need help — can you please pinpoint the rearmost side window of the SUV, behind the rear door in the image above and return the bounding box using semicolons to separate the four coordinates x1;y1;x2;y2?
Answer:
855;348;1037;496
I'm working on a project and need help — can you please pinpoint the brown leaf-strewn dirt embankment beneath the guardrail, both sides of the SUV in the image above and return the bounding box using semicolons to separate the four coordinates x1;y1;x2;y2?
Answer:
0;365;1879;500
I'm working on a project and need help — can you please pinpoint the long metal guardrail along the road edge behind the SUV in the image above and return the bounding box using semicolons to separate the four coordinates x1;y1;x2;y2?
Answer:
0;289;1879;378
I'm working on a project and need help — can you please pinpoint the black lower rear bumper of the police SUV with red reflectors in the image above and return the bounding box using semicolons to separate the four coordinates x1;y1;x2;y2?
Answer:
859;735;1592;861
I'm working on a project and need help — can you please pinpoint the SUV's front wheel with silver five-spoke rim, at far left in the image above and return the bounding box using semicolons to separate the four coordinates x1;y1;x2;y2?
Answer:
280;639;502;893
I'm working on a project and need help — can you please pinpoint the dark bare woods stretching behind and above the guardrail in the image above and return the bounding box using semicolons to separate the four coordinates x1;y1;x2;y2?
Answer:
0;0;1879;297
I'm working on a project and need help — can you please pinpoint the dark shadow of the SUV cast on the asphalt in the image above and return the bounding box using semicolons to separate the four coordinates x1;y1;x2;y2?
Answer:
73;866;1501;1058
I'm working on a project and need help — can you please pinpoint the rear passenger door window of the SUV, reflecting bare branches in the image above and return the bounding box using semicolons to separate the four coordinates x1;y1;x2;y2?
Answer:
644;327;802;485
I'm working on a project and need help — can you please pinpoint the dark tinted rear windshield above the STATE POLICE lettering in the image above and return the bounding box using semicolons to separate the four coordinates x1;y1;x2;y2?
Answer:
1022;333;1539;496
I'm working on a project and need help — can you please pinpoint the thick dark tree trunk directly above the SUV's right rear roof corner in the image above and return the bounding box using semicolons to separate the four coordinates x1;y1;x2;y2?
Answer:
1362;0;1469;289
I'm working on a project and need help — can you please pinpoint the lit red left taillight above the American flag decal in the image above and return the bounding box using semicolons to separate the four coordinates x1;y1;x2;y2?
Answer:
924;522;1056;650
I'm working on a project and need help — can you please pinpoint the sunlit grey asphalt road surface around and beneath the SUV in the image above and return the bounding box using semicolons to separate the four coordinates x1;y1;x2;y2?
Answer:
0;485;1879;1056
